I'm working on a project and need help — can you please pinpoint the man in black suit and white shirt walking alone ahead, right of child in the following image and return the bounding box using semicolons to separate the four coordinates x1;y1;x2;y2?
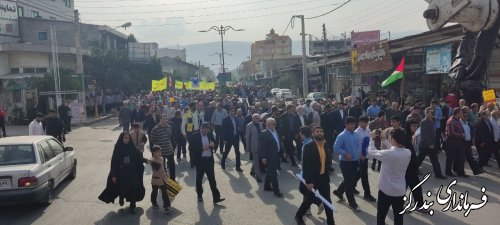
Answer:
189;122;225;204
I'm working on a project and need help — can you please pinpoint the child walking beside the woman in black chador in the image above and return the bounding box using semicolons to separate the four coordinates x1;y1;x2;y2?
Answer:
150;145;172;213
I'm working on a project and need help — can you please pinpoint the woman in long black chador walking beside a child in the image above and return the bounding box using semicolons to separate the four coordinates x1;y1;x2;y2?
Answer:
99;132;145;213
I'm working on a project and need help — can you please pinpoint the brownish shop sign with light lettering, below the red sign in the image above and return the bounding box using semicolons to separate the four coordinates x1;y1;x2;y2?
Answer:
351;41;393;73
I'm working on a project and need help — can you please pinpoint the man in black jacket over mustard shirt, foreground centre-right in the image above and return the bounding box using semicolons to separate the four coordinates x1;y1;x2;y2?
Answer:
295;127;335;225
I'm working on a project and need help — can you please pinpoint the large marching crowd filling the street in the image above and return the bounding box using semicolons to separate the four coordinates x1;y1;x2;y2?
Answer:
101;86;500;224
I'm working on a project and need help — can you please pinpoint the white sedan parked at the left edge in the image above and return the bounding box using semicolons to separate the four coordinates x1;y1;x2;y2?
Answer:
0;136;77;205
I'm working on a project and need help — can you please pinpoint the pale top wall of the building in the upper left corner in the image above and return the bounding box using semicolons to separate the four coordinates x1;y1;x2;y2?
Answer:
17;0;75;21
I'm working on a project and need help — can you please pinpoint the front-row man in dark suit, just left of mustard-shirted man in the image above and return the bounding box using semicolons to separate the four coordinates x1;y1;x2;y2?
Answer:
259;118;284;198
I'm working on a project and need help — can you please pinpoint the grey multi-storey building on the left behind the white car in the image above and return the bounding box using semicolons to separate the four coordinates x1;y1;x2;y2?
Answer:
0;17;127;122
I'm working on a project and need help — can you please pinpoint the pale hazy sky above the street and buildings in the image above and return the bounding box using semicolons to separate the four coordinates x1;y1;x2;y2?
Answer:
75;0;428;47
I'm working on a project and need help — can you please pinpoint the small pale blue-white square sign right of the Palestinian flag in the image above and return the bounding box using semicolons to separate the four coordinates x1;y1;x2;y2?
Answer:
425;44;451;74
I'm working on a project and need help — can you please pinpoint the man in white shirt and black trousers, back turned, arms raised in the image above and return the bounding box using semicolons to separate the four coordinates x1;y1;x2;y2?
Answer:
368;128;411;224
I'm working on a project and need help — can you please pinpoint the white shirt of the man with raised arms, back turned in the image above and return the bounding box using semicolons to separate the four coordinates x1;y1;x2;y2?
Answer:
368;140;411;197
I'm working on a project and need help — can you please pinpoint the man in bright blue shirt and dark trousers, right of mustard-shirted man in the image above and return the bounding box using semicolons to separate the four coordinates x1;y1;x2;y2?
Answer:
333;116;360;212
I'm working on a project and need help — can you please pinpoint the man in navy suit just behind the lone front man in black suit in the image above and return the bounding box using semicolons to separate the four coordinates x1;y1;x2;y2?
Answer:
221;107;243;172
